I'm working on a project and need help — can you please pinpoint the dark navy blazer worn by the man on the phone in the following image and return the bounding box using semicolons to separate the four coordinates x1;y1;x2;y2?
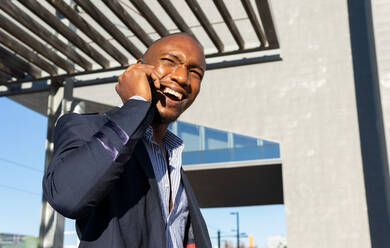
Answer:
43;100;211;248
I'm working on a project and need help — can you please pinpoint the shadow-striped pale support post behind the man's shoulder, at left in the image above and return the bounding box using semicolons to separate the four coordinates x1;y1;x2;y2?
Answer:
38;78;84;248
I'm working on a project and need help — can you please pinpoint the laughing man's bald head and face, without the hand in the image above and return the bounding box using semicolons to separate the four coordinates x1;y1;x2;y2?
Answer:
143;34;206;123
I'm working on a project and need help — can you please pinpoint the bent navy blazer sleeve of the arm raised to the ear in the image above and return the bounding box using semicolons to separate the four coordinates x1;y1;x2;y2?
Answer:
43;100;153;219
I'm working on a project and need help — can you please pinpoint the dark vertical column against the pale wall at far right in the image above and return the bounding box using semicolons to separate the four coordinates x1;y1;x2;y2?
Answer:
348;0;390;248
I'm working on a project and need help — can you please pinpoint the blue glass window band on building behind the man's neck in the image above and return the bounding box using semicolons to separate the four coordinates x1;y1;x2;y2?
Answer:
169;121;280;165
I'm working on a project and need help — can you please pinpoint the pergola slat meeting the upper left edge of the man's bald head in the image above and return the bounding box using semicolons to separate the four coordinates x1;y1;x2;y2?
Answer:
103;0;153;47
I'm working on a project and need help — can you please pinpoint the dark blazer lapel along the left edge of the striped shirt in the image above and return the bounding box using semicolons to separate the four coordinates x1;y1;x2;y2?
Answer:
133;140;166;247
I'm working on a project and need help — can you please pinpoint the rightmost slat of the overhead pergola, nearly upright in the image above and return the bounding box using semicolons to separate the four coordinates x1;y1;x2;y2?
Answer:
256;0;279;49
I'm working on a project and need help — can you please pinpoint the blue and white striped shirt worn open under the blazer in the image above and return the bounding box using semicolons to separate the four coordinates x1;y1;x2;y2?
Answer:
143;126;188;248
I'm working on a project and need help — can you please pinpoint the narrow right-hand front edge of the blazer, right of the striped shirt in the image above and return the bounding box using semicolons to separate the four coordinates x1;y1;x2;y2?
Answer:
181;169;211;248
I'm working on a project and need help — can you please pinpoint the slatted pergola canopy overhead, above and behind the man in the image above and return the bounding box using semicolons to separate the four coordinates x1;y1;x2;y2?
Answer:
0;0;280;96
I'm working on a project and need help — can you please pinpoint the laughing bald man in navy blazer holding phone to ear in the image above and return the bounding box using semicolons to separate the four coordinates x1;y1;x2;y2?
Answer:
43;34;211;248
